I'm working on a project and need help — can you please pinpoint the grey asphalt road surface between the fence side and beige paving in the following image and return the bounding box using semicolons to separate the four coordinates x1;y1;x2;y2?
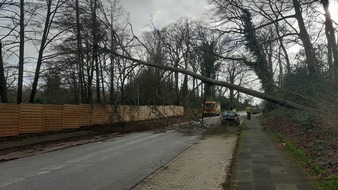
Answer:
0;131;198;190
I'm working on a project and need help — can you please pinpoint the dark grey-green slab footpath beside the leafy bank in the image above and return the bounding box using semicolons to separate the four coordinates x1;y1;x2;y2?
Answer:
232;118;314;190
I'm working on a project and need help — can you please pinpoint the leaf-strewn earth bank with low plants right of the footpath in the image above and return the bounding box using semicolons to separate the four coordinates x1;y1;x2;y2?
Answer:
262;108;338;190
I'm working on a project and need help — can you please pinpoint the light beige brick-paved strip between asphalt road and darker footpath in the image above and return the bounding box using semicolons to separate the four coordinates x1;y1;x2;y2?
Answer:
133;135;238;190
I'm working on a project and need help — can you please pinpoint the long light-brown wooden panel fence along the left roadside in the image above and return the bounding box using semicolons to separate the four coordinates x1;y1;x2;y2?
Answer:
0;104;184;137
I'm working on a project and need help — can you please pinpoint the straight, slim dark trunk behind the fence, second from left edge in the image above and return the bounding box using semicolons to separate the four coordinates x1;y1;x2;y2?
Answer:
16;0;25;104
